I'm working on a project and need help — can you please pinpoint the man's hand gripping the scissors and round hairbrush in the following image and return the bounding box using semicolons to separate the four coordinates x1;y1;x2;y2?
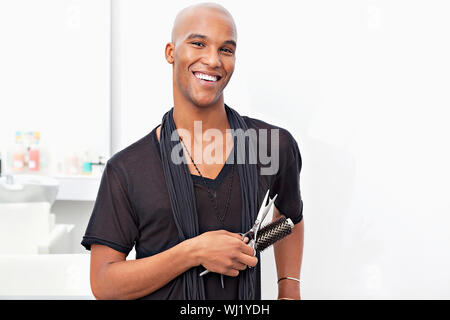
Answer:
191;230;258;277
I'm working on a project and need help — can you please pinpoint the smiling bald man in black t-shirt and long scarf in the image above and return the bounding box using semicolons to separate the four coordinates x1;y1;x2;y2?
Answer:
82;4;303;299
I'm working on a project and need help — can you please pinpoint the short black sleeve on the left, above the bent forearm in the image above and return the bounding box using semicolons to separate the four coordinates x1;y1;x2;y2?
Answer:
81;162;138;255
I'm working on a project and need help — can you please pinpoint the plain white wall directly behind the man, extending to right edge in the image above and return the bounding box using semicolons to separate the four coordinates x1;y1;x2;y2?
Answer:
112;0;450;299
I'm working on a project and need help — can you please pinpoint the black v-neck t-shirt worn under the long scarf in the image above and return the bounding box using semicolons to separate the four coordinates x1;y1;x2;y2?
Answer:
81;116;303;300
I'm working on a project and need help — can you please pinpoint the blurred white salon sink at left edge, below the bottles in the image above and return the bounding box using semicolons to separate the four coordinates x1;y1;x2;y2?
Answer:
0;174;59;205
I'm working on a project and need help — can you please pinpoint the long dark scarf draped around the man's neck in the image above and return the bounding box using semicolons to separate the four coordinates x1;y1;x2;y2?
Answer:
160;104;259;300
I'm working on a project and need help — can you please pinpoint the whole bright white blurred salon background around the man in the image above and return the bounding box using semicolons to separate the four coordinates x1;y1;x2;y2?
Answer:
0;0;450;299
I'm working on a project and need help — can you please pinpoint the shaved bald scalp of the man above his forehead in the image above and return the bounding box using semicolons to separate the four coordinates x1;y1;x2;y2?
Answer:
172;3;237;44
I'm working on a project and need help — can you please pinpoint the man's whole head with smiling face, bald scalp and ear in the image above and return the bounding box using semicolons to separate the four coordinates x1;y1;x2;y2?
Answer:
166;7;237;107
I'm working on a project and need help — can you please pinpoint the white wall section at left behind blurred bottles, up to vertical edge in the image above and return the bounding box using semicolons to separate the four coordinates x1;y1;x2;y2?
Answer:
0;0;111;176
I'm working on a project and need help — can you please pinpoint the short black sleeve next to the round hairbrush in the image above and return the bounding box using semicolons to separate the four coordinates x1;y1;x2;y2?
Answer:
270;134;303;224
